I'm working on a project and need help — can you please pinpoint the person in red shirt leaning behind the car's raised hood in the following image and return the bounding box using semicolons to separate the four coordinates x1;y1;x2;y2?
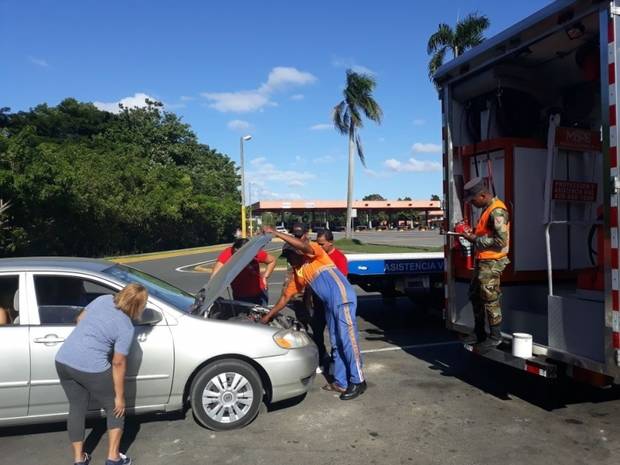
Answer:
211;239;276;305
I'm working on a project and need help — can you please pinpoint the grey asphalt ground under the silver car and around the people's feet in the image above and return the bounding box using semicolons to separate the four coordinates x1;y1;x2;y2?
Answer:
0;232;620;465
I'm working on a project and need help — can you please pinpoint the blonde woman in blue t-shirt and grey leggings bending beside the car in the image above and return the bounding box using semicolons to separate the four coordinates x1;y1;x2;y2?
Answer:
56;283;148;465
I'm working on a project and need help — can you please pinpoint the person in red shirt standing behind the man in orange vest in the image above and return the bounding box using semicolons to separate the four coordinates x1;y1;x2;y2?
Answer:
304;229;349;373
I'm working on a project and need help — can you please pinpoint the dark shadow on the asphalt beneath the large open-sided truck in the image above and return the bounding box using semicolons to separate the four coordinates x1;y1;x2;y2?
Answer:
357;296;620;411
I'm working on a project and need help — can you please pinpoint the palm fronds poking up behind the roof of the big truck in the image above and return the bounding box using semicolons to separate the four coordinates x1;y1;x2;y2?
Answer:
426;13;491;81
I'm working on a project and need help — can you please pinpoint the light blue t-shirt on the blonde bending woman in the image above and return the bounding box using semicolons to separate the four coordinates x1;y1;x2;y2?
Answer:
56;295;134;373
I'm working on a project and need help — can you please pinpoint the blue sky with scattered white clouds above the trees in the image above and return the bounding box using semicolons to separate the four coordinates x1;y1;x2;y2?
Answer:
0;0;550;200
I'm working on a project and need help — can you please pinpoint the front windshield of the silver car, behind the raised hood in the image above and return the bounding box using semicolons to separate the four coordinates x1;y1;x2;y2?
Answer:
103;265;194;313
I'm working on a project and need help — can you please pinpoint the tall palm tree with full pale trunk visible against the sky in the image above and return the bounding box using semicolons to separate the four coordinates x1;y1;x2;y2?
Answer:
333;69;383;239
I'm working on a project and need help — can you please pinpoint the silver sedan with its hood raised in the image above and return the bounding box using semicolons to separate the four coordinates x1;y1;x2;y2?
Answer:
0;236;318;430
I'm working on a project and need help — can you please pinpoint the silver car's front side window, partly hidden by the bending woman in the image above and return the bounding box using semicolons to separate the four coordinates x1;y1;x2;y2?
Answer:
34;275;116;325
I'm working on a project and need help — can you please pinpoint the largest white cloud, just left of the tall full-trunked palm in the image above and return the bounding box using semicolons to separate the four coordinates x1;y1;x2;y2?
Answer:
200;66;316;113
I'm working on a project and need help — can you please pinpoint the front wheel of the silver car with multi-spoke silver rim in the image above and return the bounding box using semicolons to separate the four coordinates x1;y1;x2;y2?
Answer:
190;360;263;431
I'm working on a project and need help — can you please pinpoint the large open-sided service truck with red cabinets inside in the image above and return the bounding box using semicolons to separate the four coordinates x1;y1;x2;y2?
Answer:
435;0;620;384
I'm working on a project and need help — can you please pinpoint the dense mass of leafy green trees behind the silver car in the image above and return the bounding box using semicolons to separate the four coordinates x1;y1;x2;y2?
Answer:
0;99;239;256
